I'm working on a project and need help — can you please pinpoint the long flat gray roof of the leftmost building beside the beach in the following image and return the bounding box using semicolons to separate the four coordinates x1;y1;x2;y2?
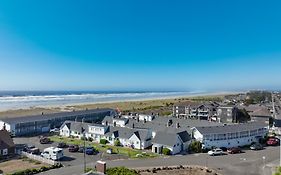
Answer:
0;108;114;124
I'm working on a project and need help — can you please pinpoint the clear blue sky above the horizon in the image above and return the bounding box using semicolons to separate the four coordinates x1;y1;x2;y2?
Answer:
0;0;281;90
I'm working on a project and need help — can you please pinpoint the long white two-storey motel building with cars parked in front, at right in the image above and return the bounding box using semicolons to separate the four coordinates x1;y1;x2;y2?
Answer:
192;122;268;148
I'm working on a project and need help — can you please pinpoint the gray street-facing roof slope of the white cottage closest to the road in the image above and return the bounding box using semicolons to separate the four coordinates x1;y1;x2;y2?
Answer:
152;132;179;147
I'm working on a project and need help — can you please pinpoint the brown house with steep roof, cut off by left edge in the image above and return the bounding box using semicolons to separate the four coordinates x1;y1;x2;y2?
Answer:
0;128;15;157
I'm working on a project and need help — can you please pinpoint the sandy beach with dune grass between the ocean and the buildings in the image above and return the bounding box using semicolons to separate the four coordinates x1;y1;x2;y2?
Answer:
0;92;238;118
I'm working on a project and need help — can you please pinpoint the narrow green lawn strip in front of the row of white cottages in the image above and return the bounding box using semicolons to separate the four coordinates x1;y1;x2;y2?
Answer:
49;136;159;158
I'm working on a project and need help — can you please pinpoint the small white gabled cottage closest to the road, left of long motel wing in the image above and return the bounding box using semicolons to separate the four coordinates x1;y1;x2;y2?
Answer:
152;131;191;154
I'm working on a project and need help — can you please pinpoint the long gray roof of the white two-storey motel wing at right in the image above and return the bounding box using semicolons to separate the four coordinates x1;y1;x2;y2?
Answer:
196;122;268;135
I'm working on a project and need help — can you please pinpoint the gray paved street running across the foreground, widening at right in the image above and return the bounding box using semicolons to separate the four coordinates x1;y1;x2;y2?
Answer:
42;147;279;175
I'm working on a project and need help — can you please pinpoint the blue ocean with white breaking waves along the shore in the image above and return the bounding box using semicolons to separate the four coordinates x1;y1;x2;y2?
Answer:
0;91;203;111
